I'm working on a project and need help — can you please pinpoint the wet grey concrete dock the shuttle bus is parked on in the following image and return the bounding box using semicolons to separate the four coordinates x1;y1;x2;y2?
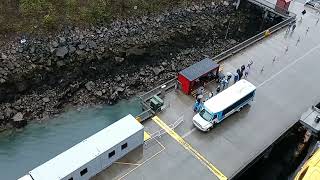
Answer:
93;1;320;180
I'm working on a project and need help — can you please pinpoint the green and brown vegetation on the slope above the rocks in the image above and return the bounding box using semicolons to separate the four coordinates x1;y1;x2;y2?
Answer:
0;0;199;34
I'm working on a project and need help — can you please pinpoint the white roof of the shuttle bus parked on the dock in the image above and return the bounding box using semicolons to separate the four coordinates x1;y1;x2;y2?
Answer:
204;79;256;113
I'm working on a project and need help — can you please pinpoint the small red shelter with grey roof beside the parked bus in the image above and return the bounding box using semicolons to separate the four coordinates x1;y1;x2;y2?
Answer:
178;58;219;94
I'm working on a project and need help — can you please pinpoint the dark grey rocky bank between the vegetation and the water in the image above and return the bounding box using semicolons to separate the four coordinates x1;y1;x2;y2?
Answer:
0;1;279;130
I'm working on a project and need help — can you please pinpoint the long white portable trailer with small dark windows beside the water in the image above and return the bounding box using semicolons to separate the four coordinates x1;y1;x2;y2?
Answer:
21;114;144;180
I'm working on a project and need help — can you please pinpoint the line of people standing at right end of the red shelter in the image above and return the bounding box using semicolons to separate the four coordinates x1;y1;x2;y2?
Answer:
216;60;253;93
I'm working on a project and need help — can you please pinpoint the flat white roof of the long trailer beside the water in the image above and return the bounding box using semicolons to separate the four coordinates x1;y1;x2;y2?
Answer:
29;115;143;180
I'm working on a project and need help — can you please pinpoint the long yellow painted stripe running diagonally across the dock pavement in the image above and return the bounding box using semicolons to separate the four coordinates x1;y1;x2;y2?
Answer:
152;116;228;180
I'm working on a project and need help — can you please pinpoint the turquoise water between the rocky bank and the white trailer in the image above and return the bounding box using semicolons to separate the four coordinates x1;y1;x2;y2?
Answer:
0;100;141;180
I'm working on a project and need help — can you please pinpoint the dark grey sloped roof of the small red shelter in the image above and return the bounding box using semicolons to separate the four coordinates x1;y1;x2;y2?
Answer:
179;58;219;81
